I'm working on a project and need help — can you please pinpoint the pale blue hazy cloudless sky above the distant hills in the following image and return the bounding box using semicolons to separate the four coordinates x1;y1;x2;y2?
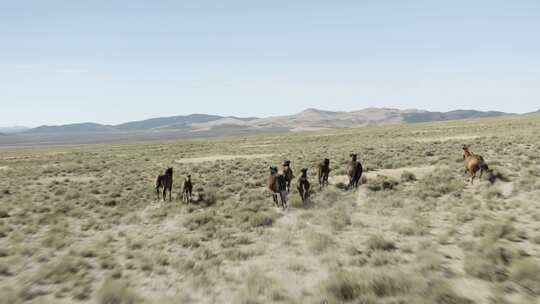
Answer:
0;0;540;126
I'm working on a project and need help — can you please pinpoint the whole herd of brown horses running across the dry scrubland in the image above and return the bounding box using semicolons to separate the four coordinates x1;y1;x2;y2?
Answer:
156;146;489;209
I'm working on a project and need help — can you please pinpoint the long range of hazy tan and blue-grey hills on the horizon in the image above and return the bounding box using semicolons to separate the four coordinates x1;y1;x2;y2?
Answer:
24;108;510;135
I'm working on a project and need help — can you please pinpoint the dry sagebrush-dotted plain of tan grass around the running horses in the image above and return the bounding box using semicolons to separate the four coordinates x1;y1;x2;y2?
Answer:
0;115;540;304
